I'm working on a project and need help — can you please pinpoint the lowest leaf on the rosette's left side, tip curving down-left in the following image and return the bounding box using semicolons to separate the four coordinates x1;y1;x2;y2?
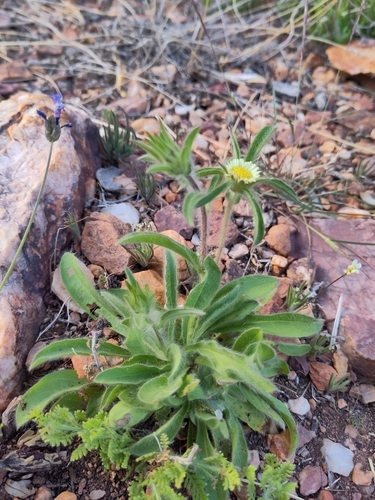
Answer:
16;370;90;427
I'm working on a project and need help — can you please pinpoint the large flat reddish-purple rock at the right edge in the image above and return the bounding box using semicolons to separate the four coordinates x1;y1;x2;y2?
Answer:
296;219;375;383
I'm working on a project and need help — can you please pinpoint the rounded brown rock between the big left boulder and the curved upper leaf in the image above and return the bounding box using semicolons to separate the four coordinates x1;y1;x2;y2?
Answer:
81;212;134;275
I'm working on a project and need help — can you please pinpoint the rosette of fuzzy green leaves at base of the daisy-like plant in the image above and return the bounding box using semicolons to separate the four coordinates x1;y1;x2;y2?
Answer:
16;233;321;498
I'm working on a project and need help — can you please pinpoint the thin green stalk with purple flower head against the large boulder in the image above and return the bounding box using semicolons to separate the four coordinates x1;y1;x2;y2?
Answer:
0;94;72;291
